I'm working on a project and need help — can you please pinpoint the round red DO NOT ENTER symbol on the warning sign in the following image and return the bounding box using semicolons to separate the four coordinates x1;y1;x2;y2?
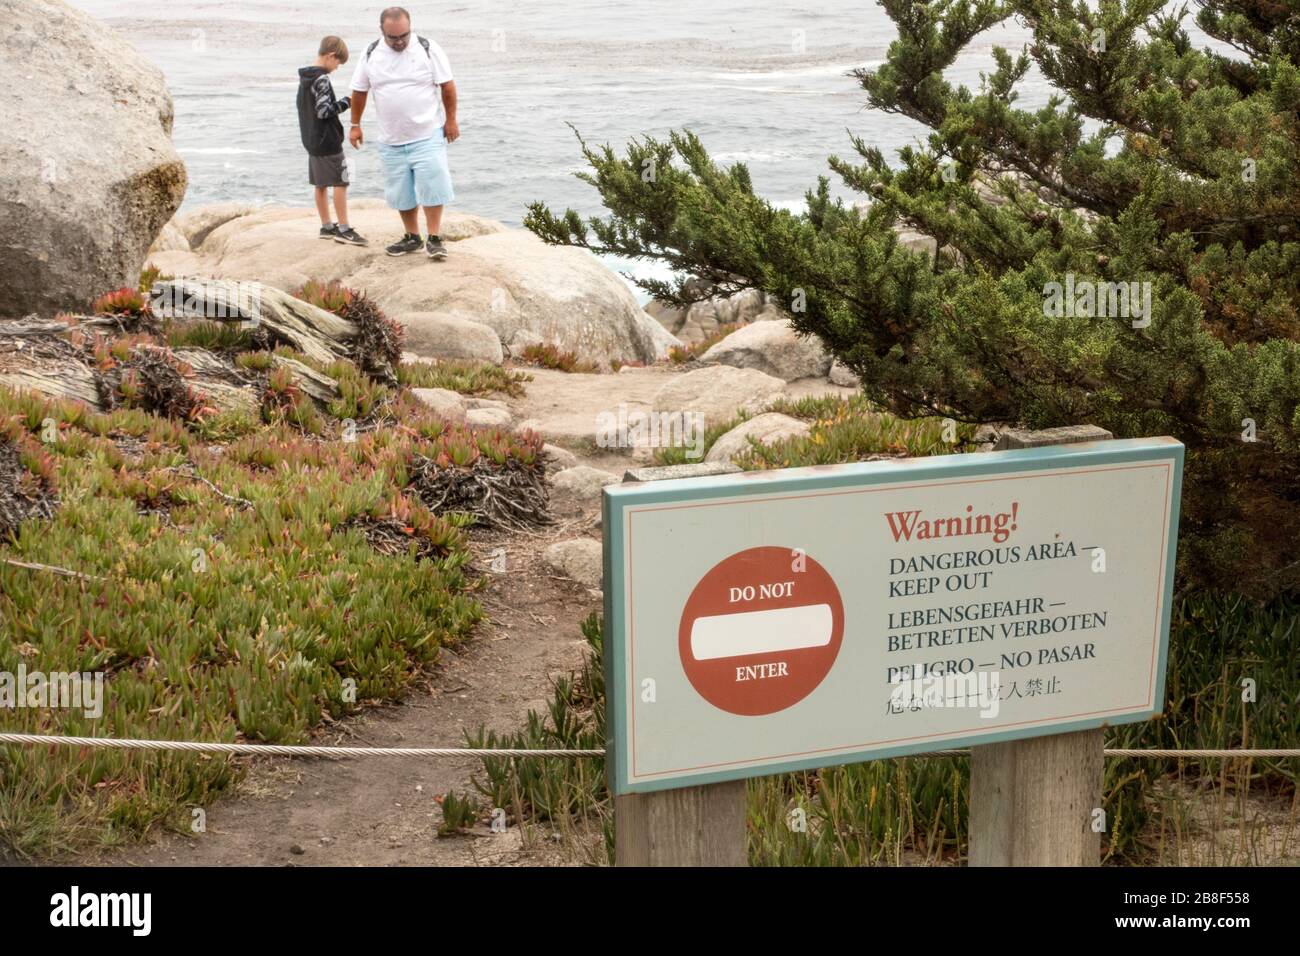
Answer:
677;548;844;717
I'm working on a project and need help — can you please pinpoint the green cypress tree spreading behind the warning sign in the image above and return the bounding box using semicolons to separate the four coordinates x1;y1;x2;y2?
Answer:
527;0;1300;597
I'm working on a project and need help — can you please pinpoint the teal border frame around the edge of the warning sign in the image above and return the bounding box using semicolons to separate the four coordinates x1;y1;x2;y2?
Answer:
601;438;1184;793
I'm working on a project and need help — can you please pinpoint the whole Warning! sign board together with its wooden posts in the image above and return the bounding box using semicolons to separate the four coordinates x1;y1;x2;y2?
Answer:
602;429;1183;865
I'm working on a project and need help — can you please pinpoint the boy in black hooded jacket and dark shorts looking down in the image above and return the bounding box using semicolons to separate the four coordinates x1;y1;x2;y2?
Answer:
298;36;367;246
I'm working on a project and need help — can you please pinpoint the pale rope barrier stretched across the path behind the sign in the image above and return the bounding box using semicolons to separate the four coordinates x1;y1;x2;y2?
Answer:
0;734;1300;760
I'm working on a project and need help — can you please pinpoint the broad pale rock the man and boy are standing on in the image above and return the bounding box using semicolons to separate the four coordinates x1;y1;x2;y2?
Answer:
169;200;679;368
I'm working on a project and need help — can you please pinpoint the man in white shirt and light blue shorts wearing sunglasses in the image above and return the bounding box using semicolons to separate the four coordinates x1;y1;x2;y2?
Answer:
348;7;460;259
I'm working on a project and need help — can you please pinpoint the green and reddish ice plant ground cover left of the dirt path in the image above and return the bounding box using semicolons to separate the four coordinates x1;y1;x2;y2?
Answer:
0;278;542;858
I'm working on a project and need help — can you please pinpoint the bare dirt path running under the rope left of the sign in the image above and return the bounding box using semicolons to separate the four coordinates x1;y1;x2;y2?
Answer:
89;522;598;866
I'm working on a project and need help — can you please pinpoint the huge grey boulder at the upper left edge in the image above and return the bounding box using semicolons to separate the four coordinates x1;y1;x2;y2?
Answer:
0;0;186;316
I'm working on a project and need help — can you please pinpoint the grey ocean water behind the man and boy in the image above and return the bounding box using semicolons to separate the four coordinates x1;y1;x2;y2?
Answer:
55;0;1222;293
